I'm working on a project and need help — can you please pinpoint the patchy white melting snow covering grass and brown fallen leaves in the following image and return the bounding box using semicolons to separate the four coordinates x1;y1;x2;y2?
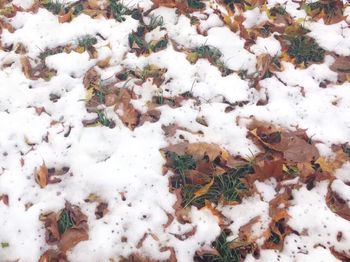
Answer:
0;0;350;262
